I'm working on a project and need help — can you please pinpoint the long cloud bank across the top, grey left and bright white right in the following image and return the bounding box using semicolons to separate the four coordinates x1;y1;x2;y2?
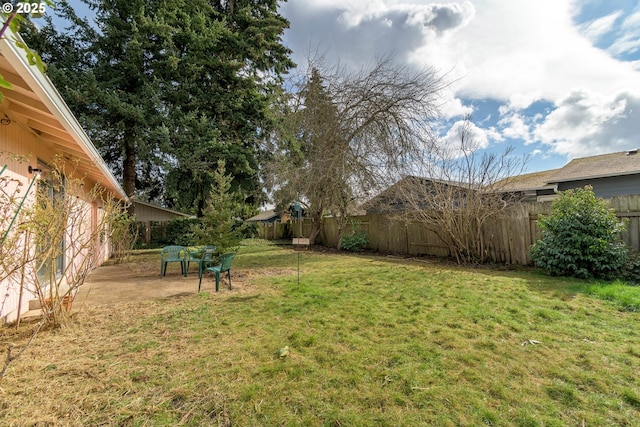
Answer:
282;0;640;102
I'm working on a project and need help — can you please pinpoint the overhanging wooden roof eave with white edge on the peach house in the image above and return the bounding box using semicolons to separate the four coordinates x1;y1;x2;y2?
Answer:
0;33;128;200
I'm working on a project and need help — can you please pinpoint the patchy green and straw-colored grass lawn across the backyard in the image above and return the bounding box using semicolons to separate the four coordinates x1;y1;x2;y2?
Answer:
0;242;640;426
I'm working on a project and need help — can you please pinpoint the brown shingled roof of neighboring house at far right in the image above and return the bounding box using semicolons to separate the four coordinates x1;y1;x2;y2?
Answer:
548;149;640;182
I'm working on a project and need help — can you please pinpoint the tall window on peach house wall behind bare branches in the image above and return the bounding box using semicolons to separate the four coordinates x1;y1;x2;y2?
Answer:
36;161;65;284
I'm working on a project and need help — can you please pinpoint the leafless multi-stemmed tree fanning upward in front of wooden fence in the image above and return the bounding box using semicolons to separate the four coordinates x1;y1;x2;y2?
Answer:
394;117;526;263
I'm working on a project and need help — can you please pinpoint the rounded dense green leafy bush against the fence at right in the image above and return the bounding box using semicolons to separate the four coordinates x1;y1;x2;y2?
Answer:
531;186;627;279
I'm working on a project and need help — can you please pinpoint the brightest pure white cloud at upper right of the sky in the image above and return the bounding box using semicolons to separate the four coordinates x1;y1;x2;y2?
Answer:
432;0;640;103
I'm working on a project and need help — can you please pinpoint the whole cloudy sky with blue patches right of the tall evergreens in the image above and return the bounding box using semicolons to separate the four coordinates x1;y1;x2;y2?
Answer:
280;0;640;172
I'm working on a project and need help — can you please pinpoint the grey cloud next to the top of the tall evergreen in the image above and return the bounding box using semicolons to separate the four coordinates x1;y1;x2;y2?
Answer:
281;0;474;68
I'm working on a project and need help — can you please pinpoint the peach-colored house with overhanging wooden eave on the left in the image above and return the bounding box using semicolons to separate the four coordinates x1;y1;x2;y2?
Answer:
0;29;128;322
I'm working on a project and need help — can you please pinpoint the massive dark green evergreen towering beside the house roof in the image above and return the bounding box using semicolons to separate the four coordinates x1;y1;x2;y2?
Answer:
23;0;293;215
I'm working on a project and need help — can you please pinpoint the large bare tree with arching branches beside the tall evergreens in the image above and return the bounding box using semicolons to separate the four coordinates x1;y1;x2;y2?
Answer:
269;58;444;244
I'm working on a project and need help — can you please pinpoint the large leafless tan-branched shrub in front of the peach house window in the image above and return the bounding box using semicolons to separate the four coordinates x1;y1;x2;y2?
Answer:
0;156;133;380
